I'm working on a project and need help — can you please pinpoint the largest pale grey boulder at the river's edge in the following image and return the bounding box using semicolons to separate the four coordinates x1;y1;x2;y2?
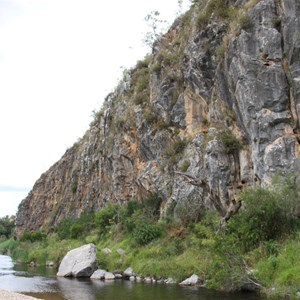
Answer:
57;244;97;277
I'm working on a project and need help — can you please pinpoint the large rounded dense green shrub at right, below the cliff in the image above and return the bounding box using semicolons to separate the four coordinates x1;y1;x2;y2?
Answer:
228;188;294;251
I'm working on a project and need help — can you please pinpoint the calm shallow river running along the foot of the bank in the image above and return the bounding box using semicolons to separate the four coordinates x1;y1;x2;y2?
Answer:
0;255;263;300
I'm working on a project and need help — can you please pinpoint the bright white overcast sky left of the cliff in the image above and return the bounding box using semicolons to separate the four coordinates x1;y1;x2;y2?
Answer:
0;0;189;217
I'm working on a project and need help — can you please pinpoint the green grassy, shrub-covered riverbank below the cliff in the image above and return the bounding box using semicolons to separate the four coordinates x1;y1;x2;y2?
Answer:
0;177;300;296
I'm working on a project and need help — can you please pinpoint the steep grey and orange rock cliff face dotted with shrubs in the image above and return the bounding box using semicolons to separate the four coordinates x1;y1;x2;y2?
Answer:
16;0;300;235
